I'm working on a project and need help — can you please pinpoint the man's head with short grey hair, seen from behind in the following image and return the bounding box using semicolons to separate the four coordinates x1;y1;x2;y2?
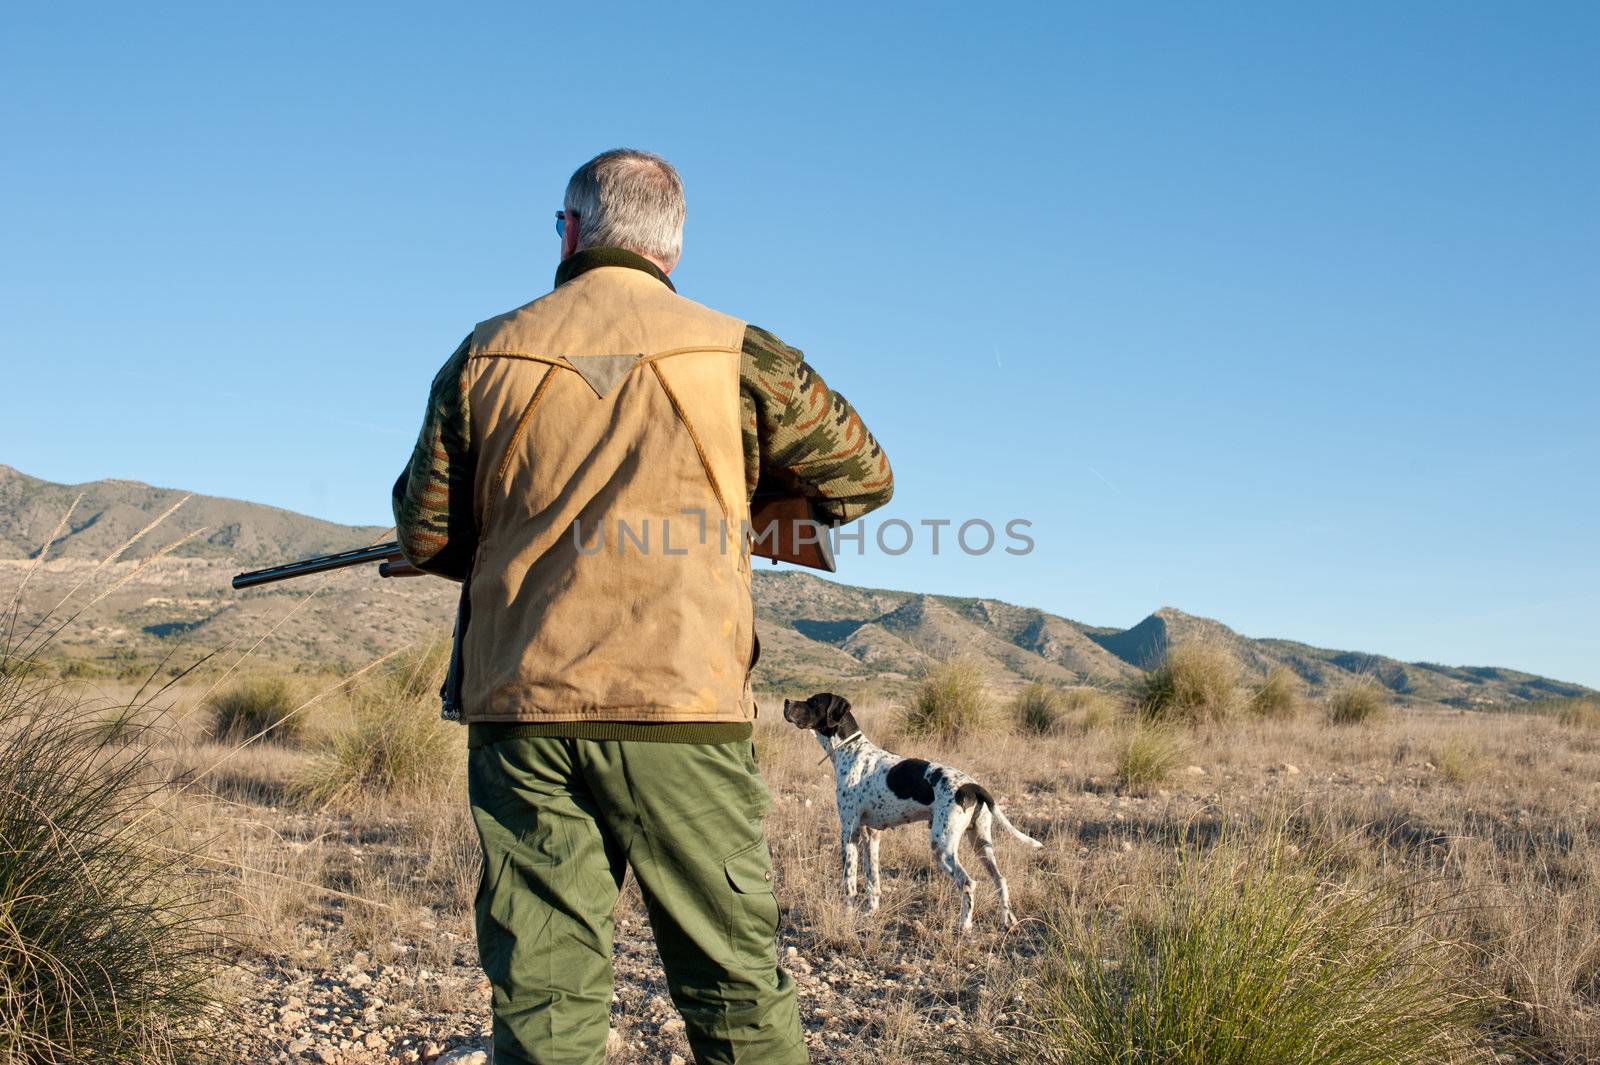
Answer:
565;149;685;265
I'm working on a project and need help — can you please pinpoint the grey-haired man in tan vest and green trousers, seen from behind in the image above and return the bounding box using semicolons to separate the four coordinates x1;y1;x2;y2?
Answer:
394;150;893;1065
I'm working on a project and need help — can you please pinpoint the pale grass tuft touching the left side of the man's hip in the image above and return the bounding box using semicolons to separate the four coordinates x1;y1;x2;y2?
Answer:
298;646;466;804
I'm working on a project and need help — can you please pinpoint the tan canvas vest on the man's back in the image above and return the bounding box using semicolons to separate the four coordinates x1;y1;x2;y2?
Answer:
462;265;755;721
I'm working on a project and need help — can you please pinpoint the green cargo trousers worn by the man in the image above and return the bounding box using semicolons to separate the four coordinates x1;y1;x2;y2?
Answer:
469;737;808;1065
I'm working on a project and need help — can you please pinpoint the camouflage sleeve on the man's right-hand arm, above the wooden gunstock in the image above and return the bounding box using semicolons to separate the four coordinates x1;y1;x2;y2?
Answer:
739;326;894;521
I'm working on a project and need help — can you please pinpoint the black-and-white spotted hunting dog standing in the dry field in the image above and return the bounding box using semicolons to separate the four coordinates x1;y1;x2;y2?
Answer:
784;692;1045;932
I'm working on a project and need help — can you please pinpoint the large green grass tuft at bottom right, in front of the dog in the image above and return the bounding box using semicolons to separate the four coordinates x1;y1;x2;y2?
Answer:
978;836;1496;1065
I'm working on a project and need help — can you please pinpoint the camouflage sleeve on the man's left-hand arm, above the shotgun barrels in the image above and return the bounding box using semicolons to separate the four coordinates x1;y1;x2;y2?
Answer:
394;336;477;580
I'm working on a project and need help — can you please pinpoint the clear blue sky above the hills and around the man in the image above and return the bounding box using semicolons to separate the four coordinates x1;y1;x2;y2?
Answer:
0;3;1600;686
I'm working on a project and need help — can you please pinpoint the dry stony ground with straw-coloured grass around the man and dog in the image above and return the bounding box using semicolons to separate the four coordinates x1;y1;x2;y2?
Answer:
121;684;1600;1065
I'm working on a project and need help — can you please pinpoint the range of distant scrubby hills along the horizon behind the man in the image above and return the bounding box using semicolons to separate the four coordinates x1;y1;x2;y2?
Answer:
0;465;1592;707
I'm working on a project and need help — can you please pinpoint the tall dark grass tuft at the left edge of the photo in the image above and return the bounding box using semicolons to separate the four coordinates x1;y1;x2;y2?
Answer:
0;511;216;1065
